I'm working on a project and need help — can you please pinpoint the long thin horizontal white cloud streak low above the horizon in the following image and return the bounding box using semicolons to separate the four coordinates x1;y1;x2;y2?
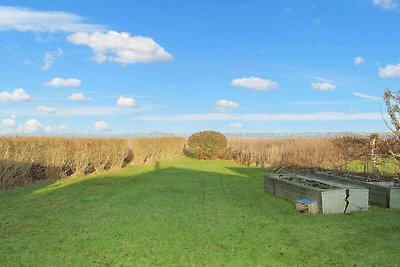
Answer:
134;112;382;122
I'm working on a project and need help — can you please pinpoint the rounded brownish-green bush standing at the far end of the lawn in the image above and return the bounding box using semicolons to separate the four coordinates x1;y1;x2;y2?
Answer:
188;131;228;159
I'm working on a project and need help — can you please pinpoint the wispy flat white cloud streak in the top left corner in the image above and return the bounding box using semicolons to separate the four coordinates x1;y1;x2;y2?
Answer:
0;6;104;32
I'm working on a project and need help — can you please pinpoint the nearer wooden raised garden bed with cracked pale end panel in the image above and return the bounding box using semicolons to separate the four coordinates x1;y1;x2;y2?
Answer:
264;174;368;214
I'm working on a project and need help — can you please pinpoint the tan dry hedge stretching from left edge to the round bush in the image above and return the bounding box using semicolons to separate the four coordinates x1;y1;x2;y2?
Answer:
0;137;186;189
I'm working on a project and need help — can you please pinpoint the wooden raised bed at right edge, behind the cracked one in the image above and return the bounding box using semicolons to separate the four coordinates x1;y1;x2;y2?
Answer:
315;172;400;209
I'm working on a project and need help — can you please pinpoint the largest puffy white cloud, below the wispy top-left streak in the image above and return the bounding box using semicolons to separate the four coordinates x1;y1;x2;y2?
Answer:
68;31;172;64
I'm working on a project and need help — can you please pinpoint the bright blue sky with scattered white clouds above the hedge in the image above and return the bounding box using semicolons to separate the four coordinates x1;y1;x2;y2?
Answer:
0;0;400;135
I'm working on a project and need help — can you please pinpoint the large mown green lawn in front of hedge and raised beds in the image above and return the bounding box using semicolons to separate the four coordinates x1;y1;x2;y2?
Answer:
0;158;400;266
